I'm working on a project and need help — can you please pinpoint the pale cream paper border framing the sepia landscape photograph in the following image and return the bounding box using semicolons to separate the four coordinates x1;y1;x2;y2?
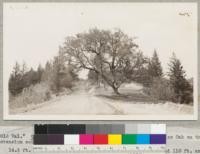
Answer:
3;1;198;121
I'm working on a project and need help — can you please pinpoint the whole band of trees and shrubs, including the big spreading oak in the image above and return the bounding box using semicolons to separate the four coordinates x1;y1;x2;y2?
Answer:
8;28;193;107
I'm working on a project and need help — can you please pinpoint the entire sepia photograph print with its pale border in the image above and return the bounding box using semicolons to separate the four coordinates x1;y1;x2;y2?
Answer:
3;2;198;120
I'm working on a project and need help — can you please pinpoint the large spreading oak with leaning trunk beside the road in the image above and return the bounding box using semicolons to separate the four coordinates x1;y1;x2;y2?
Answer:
63;28;138;94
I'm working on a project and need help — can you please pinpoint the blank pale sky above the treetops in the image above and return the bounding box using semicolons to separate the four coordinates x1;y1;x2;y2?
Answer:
3;3;197;77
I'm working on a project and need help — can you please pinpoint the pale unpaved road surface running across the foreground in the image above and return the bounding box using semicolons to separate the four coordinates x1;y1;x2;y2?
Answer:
14;86;193;115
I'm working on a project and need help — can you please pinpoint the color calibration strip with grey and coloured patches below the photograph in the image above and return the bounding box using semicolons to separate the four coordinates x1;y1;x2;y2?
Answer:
33;124;166;145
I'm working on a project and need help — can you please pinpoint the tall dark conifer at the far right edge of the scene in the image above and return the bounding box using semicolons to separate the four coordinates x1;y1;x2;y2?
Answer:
169;53;193;103
